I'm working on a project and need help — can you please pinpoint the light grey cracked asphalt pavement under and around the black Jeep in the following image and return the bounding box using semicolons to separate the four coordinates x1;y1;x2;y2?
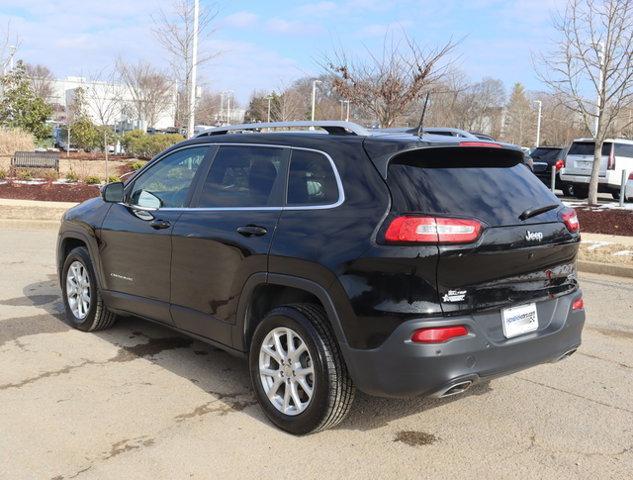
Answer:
0;223;633;480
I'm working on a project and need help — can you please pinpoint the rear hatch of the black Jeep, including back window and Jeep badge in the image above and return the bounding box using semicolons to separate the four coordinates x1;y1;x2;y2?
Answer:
387;147;580;314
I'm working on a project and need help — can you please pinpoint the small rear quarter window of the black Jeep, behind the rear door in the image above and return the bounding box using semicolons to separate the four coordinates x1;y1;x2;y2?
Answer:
287;150;339;205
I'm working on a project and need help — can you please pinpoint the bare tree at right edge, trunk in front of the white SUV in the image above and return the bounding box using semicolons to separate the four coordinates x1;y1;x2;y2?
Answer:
539;0;633;204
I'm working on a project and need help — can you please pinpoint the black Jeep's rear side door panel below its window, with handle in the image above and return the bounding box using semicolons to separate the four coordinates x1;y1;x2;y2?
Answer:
171;210;280;341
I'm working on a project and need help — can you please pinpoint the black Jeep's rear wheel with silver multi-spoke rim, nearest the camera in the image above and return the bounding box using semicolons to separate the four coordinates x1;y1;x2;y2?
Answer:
249;303;355;435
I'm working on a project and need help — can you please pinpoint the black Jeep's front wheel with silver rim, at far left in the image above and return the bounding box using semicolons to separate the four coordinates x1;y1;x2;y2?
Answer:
61;247;116;332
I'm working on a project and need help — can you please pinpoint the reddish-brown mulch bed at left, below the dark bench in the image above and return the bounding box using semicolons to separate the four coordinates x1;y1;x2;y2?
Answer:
0;183;99;202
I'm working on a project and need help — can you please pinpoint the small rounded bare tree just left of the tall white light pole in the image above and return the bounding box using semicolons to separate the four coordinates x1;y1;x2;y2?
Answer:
117;59;176;127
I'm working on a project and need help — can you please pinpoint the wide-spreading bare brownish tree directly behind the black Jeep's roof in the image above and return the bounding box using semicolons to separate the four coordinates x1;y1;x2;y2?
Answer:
322;34;455;127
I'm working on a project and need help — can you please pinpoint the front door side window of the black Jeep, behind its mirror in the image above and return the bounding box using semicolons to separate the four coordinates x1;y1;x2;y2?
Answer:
130;147;209;208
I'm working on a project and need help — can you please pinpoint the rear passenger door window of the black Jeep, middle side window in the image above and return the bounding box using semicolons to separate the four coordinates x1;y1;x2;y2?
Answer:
197;145;287;208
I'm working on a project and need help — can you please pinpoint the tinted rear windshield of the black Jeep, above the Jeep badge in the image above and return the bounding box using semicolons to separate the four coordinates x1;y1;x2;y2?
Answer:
387;156;559;227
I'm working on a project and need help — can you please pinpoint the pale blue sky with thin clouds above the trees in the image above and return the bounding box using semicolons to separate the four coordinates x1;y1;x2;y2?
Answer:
0;0;565;102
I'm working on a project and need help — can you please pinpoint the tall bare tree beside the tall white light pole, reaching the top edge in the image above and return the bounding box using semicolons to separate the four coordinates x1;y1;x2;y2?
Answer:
152;0;218;133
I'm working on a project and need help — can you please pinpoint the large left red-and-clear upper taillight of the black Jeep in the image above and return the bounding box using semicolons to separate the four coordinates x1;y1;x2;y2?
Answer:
385;217;482;243
